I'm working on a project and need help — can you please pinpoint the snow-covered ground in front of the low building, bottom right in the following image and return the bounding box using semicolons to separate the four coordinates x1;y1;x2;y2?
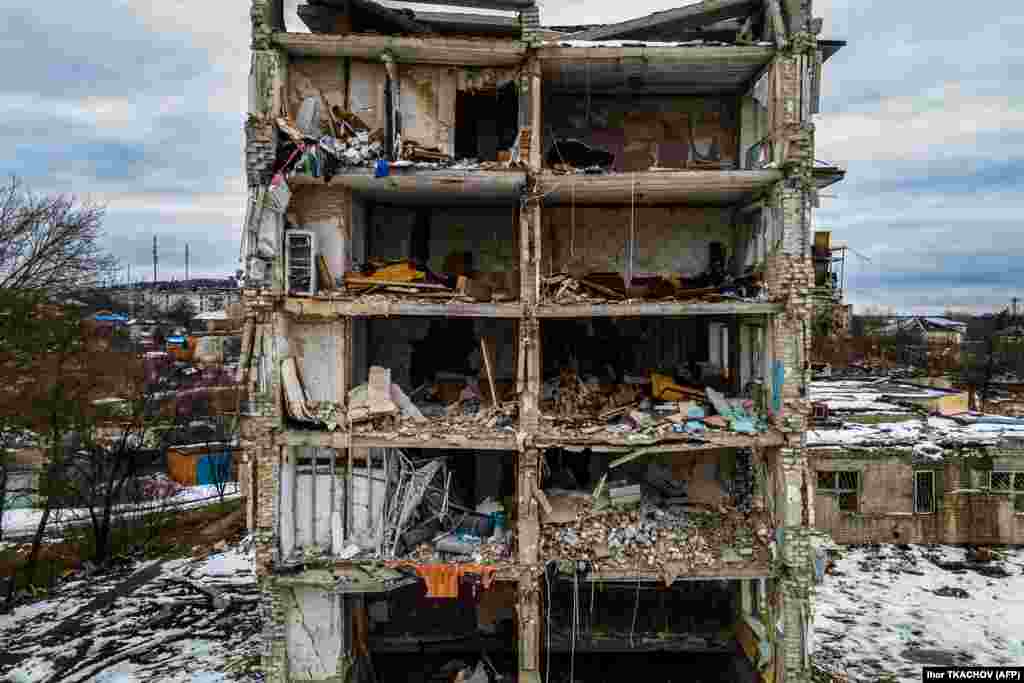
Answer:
813;545;1024;682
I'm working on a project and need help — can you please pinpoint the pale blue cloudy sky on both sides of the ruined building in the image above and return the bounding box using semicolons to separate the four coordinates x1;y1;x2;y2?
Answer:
0;0;1024;312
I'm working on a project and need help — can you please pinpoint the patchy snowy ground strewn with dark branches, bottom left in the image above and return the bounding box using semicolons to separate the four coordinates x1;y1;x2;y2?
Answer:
0;541;262;683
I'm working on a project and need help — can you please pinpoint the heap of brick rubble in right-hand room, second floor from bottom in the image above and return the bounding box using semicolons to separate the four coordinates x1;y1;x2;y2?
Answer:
541;450;774;581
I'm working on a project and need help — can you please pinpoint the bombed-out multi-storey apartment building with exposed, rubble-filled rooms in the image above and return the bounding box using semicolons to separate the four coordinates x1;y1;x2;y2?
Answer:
235;0;843;683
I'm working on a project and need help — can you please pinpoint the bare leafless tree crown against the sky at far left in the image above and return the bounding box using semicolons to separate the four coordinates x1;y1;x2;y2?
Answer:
0;177;116;294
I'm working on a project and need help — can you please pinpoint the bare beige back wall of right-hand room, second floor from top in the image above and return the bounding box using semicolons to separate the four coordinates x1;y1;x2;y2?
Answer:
542;206;731;276
